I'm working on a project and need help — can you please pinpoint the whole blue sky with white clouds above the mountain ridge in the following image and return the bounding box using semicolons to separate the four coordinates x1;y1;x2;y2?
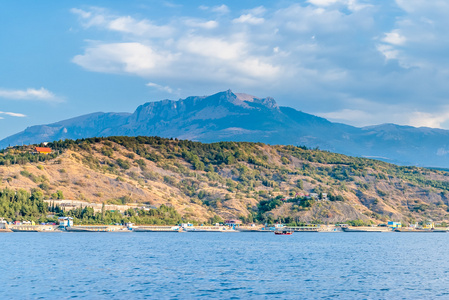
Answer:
0;0;449;139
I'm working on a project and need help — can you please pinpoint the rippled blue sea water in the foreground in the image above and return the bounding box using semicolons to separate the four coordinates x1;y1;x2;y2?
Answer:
0;232;449;299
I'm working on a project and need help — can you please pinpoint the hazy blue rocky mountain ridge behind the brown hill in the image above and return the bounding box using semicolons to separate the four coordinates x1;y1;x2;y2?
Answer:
0;90;449;168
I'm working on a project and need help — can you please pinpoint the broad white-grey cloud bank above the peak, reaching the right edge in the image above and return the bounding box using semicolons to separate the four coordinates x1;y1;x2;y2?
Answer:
72;0;449;127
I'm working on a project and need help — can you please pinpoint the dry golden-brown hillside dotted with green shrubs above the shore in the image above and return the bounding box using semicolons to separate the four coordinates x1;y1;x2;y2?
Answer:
0;137;449;223
